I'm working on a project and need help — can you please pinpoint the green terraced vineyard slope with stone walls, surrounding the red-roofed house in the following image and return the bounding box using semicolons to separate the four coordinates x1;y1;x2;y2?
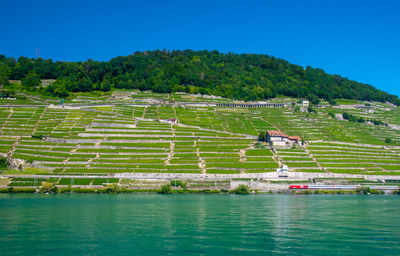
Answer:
0;90;400;177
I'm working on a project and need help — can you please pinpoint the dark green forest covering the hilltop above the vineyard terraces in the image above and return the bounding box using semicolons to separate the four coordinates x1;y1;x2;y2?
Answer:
0;50;400;105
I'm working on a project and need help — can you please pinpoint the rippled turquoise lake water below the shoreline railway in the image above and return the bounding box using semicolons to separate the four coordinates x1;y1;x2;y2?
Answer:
0;194;400;255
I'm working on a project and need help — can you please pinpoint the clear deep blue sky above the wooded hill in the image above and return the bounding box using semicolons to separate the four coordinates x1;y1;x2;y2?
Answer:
0;0;400;96
